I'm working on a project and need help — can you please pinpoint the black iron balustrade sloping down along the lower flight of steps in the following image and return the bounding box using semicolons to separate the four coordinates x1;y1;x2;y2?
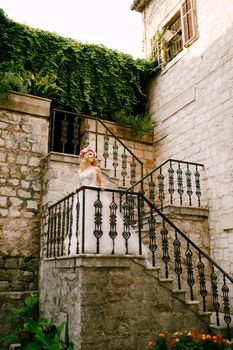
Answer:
140;194;233;339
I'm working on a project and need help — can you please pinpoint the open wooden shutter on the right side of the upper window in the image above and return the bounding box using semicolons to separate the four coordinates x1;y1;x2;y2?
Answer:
181;0;197;47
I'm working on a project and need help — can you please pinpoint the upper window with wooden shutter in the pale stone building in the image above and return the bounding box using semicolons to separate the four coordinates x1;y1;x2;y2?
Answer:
152;0;197;63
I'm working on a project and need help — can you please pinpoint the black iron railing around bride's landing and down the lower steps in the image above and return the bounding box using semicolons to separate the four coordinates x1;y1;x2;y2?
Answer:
45;186;233;338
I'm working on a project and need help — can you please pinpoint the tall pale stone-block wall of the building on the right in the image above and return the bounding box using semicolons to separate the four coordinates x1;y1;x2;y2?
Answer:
138;0;233;273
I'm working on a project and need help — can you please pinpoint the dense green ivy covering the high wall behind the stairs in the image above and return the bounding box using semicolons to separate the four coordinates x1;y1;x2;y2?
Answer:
0;9;155;121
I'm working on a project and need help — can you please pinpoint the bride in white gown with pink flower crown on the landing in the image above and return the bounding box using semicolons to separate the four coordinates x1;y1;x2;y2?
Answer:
64;147;149;255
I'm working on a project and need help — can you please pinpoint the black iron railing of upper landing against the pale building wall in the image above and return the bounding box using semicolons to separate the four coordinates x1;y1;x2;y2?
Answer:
129;159;204;210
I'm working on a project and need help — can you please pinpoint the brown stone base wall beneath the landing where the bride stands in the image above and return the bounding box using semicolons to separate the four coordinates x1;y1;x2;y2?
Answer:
40;255;207;350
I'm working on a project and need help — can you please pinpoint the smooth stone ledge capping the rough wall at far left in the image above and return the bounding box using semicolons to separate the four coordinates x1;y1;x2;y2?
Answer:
0;91;51;118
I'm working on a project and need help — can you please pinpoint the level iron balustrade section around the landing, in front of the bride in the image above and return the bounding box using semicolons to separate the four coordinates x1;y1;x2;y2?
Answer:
45;186;142;258
